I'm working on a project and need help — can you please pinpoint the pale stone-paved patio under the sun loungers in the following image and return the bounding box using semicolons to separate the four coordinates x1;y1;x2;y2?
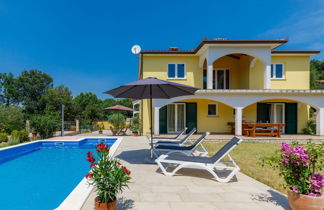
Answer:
82;136;289;210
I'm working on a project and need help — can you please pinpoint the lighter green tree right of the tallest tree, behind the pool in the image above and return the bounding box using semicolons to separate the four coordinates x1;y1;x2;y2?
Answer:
38;85;75;121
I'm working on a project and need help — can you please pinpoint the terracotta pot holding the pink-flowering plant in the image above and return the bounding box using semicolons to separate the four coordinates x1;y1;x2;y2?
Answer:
288;190;324;210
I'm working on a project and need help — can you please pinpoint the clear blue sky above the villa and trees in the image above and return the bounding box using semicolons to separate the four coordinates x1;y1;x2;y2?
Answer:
0;0;324;98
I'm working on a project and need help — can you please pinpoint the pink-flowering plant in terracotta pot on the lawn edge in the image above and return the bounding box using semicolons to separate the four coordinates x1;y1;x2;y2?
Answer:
262;141;324;210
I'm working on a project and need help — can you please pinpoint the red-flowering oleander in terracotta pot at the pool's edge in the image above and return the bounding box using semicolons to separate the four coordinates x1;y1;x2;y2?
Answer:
86;143;131;210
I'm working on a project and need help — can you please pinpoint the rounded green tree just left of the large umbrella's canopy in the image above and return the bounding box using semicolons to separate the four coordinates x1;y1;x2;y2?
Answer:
73;92;103;124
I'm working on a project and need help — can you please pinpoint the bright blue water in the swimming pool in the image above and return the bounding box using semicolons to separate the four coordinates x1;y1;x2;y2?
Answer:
0;139;116;210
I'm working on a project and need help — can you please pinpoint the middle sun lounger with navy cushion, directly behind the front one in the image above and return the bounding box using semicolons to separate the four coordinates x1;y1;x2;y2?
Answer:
153;132;209;156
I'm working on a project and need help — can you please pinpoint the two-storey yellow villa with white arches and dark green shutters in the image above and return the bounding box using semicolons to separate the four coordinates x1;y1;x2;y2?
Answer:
135;39;324;135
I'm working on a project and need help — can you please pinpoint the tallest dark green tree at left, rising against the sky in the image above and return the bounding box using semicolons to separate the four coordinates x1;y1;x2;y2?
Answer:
17;69;53;114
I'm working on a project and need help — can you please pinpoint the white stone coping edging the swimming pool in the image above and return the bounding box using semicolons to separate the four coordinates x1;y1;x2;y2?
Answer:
0;136;123;210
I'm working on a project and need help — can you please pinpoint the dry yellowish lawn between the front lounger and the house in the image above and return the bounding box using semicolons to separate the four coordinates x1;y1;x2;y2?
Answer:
204;142;286;193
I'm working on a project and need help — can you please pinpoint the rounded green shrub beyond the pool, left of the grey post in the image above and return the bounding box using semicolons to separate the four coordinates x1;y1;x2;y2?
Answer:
31;114;60;138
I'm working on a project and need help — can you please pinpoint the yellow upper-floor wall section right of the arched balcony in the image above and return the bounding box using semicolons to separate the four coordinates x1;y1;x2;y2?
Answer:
271;56;310;89
